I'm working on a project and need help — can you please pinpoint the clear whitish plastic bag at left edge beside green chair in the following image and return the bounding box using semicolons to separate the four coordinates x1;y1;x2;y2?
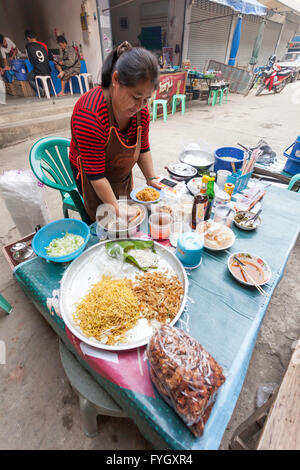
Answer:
0;170;50;237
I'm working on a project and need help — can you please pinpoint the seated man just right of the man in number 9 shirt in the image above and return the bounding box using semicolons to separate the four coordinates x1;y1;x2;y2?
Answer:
56;36;80;96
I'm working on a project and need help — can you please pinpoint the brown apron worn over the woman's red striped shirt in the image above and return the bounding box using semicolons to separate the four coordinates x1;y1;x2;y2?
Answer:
73;90;142;222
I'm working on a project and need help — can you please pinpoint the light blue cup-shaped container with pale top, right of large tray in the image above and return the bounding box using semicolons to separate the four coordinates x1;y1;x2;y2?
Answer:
176;232;204;269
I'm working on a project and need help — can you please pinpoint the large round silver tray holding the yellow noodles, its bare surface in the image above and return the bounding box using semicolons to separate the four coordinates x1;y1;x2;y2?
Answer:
59;238;188;351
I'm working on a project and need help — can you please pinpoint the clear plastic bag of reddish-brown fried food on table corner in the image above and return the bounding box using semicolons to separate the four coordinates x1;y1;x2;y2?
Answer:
147;325;225;436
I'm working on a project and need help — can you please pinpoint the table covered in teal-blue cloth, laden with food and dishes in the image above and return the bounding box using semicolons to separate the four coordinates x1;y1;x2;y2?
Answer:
14;187;300;450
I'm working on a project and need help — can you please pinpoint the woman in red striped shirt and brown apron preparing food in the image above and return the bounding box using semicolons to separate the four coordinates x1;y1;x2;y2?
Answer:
70;42;160;220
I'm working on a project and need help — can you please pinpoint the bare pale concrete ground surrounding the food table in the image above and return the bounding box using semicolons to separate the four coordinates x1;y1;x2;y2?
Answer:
0;88;300;450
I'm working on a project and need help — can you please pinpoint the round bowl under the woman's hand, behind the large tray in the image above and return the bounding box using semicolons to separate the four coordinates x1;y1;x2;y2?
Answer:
96;199;147;240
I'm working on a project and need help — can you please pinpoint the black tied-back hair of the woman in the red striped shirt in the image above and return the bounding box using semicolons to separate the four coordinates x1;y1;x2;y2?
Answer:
101;41;159;88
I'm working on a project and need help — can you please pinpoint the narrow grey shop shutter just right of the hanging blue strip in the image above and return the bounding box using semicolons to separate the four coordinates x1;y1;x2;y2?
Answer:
236;15;261;67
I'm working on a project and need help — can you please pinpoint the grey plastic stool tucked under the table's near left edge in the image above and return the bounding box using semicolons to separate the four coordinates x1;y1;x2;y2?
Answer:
59;340;127;437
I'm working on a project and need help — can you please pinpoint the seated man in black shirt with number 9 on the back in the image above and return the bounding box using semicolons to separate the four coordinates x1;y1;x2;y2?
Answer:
24;29;53;96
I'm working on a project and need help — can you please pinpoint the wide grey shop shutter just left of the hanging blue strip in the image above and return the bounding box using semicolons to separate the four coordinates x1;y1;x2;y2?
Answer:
187;0;233;71
